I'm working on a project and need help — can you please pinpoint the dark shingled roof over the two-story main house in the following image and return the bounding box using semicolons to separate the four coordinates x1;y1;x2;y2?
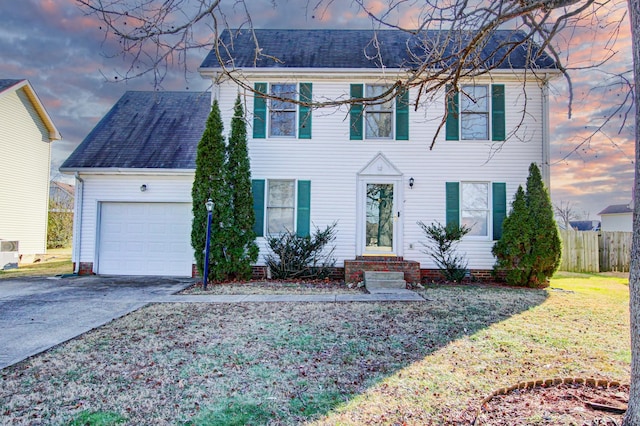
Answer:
201;29;555;69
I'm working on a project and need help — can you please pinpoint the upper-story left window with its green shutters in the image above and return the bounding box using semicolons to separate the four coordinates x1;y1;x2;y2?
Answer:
253;83;312;139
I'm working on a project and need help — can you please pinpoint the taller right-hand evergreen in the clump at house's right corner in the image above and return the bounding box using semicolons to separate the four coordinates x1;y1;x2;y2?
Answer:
527;163;562;285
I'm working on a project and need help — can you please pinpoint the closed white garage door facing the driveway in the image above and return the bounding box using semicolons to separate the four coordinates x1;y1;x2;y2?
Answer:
97;202;193;277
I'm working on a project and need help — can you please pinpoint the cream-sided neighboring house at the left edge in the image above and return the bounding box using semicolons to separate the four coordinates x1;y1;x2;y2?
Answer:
0;79;61;262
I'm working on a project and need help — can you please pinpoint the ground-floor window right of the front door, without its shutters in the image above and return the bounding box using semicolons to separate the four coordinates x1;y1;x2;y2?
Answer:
460;182;489;236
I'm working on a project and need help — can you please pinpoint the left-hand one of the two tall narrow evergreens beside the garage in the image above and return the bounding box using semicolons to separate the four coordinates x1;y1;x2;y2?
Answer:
191;100;231;281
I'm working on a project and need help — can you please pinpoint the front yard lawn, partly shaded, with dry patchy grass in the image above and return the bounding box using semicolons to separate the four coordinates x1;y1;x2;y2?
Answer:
0;275;630;425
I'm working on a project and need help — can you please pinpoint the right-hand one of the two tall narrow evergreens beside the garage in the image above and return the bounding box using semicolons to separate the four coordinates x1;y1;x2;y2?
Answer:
227;96;258;280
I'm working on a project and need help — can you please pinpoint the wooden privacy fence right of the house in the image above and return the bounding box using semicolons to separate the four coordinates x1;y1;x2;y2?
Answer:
560;230;632;273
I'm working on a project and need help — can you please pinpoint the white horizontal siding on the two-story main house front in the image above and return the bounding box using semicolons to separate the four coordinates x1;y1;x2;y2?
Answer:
218;75;544;269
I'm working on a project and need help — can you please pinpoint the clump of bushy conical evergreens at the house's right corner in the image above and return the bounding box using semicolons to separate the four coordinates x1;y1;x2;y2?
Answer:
492;163;562;287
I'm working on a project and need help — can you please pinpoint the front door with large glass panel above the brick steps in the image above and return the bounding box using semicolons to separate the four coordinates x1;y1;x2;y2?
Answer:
364;182;396;254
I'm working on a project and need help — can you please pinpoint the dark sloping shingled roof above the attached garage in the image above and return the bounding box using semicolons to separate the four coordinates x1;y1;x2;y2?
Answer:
60;92;211;171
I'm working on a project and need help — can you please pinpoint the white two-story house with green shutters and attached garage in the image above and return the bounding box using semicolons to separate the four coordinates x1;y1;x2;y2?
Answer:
61;30;557;281
